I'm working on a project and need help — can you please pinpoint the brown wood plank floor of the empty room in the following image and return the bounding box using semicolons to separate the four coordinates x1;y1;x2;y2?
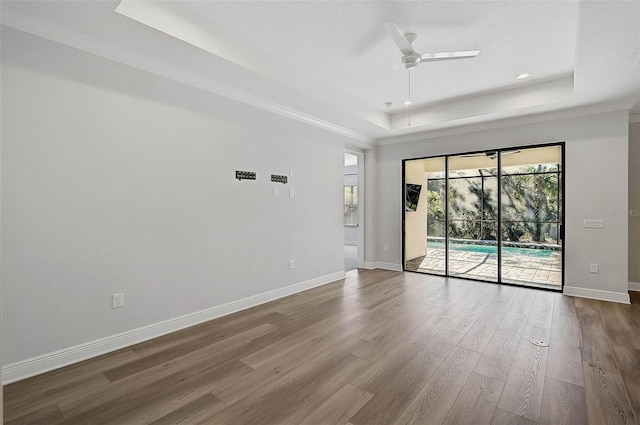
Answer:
4;270;640;425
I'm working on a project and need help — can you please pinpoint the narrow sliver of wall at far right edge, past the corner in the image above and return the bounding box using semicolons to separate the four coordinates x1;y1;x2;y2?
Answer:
629;123;640;284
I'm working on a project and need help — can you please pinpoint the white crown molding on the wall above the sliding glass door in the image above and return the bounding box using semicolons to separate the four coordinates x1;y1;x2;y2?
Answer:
375;102;630;146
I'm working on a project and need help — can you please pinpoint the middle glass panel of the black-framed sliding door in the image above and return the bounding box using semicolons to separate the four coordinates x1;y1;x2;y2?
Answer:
447;152;498;282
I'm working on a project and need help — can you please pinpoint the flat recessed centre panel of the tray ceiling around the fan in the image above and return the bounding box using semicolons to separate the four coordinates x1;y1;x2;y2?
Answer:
170;0;578;111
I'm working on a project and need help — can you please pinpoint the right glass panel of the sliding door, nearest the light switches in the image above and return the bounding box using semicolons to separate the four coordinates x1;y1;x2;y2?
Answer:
500;146;562;289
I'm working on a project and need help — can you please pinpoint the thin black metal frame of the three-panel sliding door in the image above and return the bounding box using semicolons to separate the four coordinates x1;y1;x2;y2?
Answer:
402;141;567;292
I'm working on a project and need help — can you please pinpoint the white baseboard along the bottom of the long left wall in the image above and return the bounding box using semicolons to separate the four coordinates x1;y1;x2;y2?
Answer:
2;270;345;385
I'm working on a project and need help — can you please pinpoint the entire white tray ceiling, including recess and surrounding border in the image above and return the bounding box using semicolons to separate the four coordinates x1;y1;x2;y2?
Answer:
2;0;640;146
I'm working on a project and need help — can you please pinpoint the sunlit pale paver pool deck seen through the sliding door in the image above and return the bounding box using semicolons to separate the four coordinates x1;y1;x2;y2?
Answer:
405;248;562;289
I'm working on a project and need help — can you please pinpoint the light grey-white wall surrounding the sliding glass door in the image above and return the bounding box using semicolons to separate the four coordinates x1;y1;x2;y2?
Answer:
376;111;628;302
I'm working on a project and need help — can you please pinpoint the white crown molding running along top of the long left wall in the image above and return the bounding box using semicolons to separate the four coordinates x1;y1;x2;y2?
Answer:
1;7;373;144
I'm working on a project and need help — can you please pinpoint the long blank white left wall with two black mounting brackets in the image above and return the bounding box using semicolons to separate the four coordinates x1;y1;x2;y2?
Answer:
2;58;344;365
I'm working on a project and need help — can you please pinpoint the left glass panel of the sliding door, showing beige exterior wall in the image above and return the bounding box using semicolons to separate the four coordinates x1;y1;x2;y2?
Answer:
404;157;446;275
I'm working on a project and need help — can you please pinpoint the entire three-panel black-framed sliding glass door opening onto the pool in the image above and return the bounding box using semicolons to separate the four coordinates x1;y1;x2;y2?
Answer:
403;144;563;289
